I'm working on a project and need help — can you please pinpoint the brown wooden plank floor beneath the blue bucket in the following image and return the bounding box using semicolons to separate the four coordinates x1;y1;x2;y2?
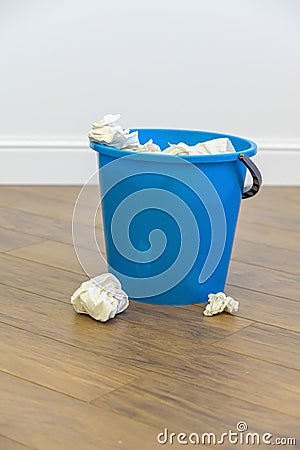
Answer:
0;186;300;450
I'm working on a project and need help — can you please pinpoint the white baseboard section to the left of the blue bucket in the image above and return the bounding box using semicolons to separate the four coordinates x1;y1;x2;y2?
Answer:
0;139;97;185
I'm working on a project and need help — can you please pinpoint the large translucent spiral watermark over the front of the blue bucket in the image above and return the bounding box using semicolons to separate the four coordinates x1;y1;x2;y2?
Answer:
72;153;227;299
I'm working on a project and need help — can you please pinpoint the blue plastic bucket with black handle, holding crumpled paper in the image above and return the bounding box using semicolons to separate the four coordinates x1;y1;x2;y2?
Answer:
90;129;261;305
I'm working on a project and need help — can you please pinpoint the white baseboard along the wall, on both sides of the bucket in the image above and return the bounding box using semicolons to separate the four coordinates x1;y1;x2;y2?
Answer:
0;138;300;186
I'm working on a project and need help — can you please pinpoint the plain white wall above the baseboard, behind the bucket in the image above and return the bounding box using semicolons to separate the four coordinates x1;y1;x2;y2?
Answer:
0;0;300;182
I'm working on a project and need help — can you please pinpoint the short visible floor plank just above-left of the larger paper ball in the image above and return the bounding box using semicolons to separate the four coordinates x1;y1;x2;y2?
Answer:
7;240;107;277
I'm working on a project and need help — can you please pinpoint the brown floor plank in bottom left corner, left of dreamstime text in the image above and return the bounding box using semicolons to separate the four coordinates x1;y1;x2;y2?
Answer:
0;373;164;450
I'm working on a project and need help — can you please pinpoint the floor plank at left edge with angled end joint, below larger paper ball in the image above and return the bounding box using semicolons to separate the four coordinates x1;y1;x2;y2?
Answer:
0;323;142;401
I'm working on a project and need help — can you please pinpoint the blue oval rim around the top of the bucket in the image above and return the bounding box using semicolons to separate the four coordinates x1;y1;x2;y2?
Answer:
89;128;257;163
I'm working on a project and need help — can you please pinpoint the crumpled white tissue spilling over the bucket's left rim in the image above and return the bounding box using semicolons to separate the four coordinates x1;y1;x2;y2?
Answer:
88;114;140;149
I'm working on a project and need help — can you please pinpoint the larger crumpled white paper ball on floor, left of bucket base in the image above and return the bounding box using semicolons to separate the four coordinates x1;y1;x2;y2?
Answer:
71;273;129;322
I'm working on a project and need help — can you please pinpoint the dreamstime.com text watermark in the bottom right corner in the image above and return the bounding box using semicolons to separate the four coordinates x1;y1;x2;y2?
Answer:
156;420;296;446
